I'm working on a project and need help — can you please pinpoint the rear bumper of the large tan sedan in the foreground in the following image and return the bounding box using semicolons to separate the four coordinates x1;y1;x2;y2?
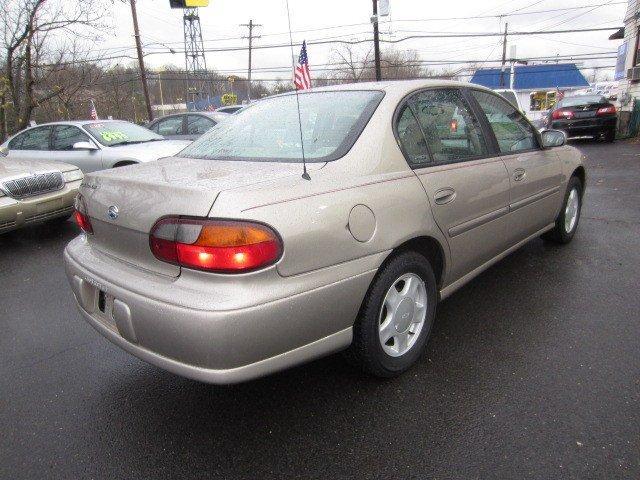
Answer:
64;236;382;384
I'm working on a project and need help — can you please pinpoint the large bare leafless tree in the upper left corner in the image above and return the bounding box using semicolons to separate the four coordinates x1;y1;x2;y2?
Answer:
0;0;109;138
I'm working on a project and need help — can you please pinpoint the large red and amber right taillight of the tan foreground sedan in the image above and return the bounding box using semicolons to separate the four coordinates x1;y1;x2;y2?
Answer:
149;217;282;273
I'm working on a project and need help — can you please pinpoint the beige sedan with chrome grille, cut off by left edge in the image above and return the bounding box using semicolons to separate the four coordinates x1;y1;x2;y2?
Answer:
0;150;83;233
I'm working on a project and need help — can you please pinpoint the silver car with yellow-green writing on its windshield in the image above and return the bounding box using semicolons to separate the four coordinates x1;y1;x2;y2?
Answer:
2;120;190;173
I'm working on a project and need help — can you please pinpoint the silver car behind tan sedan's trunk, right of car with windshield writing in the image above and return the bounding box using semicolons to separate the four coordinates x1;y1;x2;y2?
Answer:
147;112;229;140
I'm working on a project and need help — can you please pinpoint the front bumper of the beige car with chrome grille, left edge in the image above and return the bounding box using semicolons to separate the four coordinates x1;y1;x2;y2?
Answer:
0;180;81;233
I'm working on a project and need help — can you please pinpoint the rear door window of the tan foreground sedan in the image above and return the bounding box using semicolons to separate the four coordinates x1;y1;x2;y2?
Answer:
408;89;488;165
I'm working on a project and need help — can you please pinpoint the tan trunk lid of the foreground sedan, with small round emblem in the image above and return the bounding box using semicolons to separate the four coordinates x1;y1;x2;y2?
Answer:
80;158;308;276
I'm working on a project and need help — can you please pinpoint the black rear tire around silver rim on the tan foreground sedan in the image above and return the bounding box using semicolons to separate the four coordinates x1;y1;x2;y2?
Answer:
345;251;437;378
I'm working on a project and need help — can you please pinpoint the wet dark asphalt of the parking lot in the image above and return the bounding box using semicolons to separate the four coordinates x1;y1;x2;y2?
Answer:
0;142;640;479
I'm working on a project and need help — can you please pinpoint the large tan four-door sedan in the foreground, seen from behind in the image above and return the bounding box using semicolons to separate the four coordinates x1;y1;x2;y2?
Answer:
64;81;585;383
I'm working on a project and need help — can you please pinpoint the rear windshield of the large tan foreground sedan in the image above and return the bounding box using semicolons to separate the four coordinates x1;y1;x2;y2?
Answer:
178;91;384;162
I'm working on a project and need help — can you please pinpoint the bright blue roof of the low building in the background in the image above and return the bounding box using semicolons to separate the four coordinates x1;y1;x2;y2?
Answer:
471;63;589;90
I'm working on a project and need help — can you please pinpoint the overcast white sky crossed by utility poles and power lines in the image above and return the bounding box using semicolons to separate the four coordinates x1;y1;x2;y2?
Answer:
100;0;626;79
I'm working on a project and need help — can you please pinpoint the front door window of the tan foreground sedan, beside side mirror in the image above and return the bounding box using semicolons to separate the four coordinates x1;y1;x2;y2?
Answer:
473;90;538;153
